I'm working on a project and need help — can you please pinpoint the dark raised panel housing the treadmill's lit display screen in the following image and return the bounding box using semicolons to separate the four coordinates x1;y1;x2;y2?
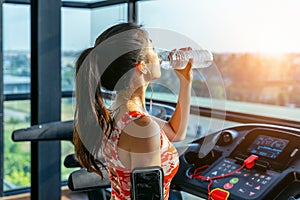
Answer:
230;128;300;172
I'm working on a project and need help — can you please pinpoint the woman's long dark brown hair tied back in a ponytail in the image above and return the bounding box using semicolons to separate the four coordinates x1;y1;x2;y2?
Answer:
73;23;149;178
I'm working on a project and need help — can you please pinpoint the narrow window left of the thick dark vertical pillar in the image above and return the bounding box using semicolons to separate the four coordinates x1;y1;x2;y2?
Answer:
3;4;30;190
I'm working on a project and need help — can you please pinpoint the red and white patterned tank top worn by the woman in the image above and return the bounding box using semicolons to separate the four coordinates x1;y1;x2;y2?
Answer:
102;111;179;200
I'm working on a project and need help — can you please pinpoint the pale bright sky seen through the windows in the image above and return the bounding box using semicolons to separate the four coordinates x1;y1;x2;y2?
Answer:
3;0;300;53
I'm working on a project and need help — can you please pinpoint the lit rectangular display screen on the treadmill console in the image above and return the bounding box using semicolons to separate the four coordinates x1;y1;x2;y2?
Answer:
248;135;289;159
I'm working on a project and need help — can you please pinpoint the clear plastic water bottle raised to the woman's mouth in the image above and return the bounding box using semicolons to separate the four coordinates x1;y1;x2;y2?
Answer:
158;49;213;69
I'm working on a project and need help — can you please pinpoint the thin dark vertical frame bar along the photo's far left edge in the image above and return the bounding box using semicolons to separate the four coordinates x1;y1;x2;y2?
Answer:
0;2;4;197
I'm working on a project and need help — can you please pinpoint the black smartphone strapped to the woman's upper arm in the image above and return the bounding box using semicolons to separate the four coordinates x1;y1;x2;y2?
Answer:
131;167;164;200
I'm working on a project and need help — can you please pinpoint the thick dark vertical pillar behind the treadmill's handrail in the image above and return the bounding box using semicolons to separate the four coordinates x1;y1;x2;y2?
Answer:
31;0;61;200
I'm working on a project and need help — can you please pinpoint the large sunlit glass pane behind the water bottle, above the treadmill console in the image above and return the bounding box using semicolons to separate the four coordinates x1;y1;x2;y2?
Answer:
138;0;300;121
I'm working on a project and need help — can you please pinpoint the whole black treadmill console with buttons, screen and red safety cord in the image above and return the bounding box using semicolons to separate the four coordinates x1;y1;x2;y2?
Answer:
174;126;300;200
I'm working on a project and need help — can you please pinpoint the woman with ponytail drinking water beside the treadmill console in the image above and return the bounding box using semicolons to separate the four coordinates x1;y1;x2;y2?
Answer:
74;23;192;200
